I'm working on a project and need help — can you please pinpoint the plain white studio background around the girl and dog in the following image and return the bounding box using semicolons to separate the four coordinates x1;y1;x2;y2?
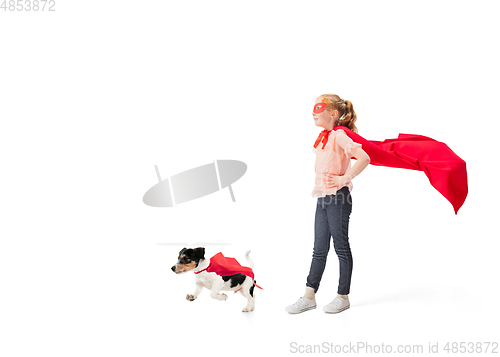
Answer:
0;0;500;356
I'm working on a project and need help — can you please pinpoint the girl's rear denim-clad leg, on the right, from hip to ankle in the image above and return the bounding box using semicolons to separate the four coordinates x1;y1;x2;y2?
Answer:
327;187;353;295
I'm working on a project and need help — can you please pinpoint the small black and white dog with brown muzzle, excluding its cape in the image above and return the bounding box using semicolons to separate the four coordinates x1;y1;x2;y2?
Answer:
172;247;255;312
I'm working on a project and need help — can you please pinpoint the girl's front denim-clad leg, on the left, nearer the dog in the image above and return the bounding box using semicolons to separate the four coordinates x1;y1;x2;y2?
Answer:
306;195;333;293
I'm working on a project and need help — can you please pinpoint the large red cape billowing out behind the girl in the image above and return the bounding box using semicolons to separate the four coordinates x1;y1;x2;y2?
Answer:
333;126;468;214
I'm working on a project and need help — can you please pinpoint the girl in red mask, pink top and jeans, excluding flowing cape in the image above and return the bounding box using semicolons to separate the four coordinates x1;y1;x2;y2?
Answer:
285;94;370;314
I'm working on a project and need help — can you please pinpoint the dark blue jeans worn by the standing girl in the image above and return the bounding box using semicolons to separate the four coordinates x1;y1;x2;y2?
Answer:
306;186;352;295
